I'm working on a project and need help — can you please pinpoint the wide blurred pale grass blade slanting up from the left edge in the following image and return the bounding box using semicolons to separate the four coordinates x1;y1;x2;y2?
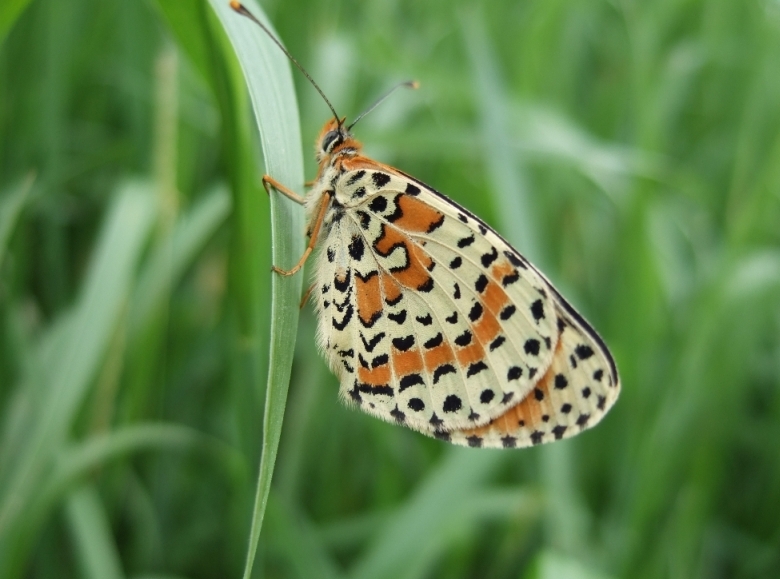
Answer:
0;183;155;577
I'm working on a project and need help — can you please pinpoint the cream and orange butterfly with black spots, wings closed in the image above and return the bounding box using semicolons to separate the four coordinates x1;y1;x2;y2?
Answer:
231;0;620;448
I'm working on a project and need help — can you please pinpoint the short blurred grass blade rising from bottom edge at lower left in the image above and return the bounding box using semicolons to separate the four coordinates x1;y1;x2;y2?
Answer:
65;485;125;579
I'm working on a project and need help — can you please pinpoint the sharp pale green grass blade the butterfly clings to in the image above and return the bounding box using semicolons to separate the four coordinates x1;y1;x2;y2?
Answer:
210;0;304;579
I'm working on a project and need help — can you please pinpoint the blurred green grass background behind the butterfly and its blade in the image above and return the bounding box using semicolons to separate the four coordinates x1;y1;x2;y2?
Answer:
0;0;780;579
